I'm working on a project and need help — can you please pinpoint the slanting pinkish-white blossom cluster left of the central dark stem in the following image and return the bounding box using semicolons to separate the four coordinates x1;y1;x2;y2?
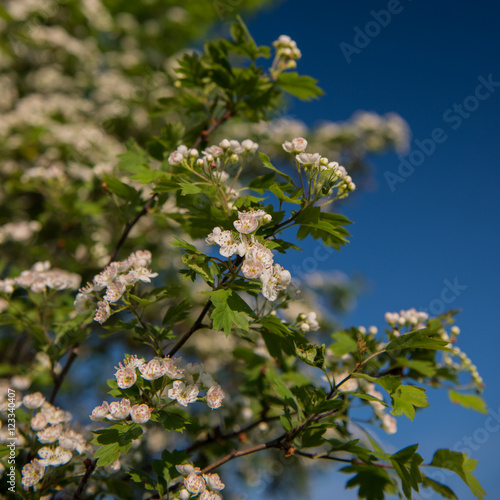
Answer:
74;250;158;325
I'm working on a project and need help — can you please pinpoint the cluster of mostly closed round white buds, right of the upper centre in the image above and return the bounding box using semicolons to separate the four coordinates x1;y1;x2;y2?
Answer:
282;137;356;199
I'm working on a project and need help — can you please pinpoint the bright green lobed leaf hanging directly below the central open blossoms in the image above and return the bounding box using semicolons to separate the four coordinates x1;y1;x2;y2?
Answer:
210;289;253;335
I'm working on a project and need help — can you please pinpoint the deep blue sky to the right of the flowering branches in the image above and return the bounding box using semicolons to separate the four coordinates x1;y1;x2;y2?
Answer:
243;0;500;500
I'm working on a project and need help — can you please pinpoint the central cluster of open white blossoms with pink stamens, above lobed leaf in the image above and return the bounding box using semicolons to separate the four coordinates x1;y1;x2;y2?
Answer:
205;210;291;301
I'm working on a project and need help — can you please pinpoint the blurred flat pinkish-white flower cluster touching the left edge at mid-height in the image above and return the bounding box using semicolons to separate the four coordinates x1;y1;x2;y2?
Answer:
0;261;81;294
